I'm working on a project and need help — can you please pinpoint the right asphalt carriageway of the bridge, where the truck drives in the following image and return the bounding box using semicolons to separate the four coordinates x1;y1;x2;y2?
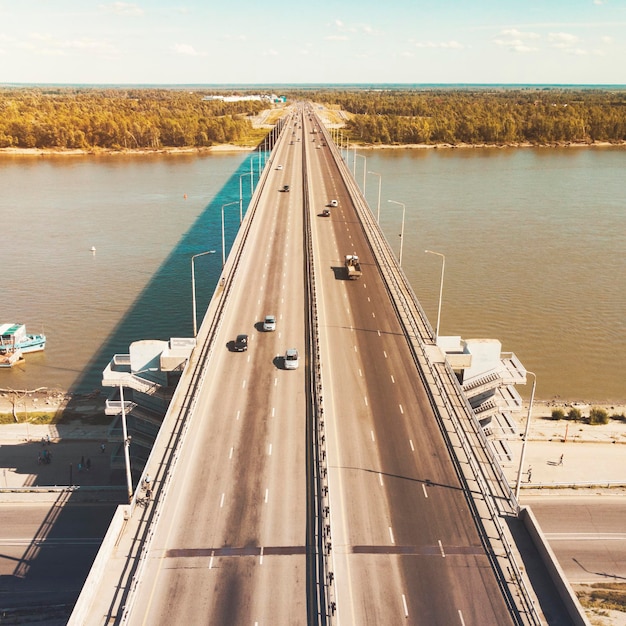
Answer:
308;109;512;625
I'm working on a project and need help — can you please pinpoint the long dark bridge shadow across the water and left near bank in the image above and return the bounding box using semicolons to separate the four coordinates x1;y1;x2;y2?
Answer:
0;145;268;624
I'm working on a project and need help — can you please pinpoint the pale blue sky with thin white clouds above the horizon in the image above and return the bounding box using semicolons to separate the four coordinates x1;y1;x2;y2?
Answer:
0;0;626;85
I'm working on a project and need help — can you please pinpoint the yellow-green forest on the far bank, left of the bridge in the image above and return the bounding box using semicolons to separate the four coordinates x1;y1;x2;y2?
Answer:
0;88;268;150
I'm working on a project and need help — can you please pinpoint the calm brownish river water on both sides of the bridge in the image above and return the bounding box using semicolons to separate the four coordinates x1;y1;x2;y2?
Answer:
0;148;626;402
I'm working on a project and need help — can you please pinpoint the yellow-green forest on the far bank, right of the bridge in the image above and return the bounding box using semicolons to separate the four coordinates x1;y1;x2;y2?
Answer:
301;88;626;145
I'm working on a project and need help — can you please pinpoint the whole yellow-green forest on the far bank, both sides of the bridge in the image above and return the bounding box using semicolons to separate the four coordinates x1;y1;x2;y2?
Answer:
0;87;626;150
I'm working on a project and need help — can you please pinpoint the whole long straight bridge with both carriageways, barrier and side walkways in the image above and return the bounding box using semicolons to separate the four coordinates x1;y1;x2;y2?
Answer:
70;105;585;625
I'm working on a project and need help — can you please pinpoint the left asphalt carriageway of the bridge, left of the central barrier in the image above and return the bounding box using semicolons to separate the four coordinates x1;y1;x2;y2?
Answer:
127;109;307;624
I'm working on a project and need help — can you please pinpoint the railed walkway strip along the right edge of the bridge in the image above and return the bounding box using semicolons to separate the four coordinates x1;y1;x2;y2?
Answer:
316;119;541;624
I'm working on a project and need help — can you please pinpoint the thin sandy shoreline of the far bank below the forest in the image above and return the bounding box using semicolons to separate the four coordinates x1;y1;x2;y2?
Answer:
0;141;626;157
